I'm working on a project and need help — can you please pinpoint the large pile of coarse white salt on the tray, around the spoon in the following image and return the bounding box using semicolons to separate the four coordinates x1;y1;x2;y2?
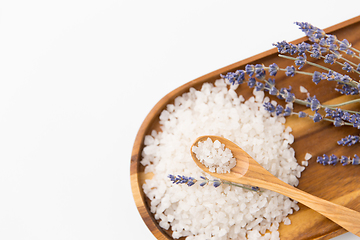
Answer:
141;80;304;240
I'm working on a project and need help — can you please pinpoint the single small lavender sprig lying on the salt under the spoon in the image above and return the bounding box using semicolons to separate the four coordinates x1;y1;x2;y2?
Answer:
168;174;260;192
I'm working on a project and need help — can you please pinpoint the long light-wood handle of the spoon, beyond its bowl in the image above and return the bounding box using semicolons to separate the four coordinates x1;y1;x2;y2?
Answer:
264;178;360;237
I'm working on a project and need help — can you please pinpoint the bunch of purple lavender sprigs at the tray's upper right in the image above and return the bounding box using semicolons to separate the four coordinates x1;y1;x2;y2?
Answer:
221;22;360;165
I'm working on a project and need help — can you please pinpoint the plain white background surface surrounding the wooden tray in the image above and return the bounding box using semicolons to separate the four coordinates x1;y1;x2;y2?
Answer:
0;0;359;240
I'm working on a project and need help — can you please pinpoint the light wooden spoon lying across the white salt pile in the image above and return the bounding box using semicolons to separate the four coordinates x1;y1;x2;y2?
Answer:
191;136;360;237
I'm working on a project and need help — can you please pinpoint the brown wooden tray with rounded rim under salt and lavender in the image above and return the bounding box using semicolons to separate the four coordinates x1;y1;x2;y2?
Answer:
130;16;360;240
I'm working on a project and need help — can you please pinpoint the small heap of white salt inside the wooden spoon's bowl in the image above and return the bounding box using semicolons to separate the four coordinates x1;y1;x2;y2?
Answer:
192;138;236;173
